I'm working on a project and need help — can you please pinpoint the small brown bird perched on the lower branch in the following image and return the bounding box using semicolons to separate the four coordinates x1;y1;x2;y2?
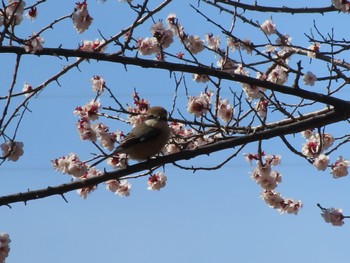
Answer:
113;106;170;161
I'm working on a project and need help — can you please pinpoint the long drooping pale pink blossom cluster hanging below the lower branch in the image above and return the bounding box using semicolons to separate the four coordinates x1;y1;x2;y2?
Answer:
245;153;302;215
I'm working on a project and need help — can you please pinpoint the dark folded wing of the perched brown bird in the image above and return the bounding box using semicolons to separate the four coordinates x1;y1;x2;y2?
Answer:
118;123;160;149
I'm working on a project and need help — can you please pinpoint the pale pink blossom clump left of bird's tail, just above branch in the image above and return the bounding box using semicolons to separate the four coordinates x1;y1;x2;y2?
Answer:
51;153;88;178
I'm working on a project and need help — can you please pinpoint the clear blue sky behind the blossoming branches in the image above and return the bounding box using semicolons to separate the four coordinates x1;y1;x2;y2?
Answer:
0;0;350;263
